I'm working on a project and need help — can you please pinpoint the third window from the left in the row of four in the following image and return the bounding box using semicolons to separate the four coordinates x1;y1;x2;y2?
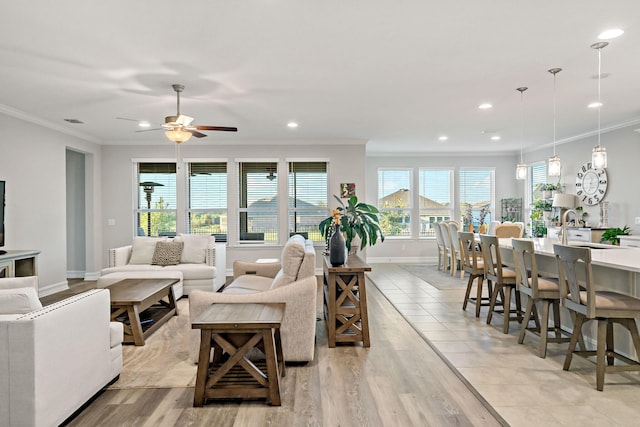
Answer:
238;162;278;243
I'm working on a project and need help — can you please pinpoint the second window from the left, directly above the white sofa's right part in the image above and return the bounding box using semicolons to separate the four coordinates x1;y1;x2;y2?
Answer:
187;162;227;242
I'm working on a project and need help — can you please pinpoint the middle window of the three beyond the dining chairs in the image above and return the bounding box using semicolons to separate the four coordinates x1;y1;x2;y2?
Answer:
418;169;453;237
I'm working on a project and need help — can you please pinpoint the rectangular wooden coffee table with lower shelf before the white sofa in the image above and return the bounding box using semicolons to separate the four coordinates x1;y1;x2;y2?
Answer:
108;279;180;345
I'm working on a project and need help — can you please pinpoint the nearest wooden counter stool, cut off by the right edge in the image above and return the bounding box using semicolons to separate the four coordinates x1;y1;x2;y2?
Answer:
553;245;640;391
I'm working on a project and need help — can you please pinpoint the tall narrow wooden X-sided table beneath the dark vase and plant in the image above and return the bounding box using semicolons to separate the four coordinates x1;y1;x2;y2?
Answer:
323;255;371;347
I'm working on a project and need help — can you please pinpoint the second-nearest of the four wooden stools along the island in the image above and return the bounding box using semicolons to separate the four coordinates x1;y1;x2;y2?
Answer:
511;239;568;358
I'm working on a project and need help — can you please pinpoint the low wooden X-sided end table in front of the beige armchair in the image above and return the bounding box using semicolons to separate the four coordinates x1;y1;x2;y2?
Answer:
191;303;285;406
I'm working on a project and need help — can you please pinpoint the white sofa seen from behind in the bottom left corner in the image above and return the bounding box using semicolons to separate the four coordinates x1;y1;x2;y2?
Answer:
0;277;123;426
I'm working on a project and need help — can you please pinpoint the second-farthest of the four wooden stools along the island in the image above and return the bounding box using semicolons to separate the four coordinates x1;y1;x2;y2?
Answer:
480;234;522;334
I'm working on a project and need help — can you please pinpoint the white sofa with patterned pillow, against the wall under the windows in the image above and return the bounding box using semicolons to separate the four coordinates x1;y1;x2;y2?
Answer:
100;234;227;295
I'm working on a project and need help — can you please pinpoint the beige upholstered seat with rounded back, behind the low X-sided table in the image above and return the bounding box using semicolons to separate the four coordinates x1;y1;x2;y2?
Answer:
189;235;318;363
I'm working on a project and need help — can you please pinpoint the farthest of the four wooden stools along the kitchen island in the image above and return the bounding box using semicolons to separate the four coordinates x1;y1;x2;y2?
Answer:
458;231;493;317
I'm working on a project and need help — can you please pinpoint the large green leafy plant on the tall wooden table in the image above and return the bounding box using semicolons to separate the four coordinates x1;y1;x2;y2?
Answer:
318;195;384;251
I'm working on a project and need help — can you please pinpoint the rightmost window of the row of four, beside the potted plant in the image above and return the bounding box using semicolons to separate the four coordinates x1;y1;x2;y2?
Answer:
288;162;328;242
